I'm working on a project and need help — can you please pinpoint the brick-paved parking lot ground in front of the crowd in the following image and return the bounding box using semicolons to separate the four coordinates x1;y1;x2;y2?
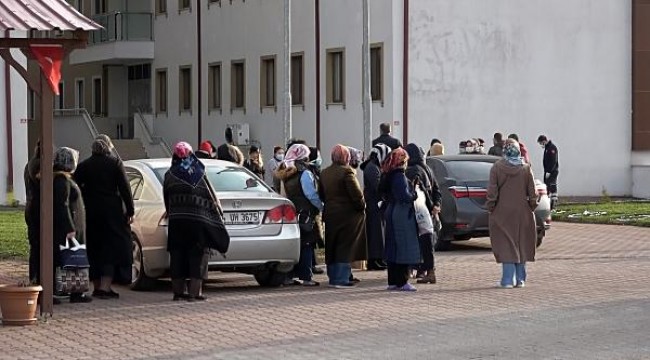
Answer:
0;223;650;359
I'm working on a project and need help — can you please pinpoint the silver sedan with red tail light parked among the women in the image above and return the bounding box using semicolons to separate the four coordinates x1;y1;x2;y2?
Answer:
124;159;300;290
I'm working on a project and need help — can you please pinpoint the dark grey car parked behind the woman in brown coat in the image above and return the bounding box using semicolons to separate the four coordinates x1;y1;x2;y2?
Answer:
427;155;551;250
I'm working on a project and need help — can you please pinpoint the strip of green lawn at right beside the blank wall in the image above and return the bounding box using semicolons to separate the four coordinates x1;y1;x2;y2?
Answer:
553;201;650;227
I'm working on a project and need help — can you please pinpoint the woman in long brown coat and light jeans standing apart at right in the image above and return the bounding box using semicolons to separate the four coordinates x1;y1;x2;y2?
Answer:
485;138;537;289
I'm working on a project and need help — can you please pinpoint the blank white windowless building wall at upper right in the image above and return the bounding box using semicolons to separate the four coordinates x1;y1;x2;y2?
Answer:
409;0;632;195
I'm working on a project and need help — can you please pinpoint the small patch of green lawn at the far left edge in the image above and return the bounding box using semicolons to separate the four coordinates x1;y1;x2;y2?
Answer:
0;209;29;259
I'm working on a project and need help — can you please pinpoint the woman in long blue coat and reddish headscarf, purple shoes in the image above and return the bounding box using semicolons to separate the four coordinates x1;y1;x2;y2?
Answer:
380;148;421;291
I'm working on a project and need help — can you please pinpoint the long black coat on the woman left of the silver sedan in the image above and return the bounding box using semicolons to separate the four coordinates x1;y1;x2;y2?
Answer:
74;155;134;276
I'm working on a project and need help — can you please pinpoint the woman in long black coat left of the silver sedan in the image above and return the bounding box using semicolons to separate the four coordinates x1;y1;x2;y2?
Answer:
74;138;134;299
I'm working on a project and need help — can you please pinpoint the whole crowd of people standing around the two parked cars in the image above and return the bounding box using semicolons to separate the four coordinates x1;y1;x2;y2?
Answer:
25;124;559;303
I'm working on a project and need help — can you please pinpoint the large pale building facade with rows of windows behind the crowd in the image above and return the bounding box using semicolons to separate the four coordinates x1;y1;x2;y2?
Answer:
17;0;650;202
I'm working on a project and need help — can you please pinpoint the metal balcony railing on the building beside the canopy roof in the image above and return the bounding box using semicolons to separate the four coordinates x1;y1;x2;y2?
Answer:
88;12;153;45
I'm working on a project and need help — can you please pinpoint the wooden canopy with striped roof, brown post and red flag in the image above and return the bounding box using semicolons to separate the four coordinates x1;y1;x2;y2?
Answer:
0;0;101;316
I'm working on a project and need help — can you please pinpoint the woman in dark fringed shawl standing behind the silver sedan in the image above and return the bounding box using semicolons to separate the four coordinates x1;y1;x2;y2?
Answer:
163;142;223;301
